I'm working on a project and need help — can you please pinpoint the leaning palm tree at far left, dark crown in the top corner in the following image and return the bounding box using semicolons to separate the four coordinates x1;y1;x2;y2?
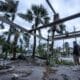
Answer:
0;0;18;58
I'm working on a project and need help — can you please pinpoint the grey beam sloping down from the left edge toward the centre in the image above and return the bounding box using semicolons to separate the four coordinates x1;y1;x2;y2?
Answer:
0;16;47;41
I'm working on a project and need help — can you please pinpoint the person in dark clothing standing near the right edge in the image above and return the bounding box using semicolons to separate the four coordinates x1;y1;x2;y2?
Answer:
73;41;79;65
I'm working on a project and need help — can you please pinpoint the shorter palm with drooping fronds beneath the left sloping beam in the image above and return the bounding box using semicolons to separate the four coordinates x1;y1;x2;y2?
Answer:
12;29;30;59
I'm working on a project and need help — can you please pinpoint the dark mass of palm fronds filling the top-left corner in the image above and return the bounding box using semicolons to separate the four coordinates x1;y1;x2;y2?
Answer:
0;0;19;13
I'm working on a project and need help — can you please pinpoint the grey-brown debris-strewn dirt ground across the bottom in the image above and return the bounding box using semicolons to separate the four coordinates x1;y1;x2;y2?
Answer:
0;60;80;80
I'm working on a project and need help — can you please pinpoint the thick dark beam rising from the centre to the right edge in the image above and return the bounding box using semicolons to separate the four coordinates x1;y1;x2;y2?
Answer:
29;13;80;32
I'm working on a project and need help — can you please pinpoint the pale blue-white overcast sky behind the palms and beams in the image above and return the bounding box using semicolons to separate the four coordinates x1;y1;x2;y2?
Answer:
0;0;80;46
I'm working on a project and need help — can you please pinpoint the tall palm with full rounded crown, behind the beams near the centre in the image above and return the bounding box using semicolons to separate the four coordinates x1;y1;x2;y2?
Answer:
19;5;49;58
